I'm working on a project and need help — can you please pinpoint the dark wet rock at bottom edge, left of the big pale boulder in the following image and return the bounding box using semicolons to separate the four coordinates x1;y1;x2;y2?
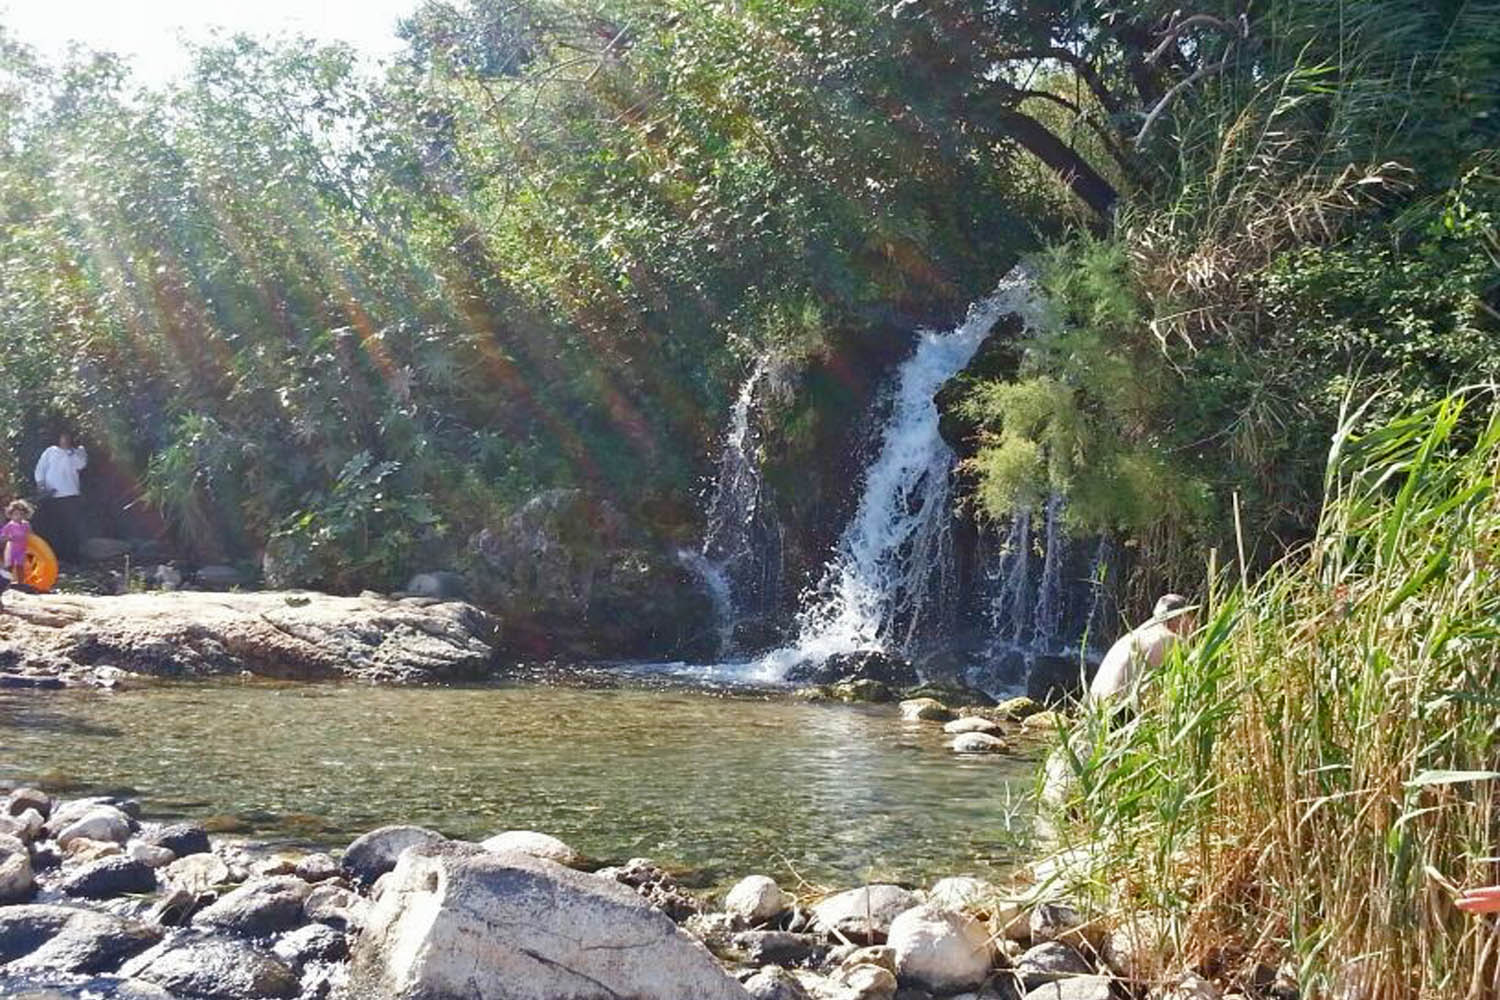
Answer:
120;939;302;1000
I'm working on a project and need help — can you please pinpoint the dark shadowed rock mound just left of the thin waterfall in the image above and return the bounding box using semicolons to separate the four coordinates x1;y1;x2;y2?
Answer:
468;489;717;660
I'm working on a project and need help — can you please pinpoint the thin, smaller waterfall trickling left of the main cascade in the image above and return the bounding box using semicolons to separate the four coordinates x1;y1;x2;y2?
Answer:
678;360;782;657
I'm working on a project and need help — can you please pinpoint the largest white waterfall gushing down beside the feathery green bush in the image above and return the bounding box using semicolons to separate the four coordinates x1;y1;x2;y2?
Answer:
756;268;1038;681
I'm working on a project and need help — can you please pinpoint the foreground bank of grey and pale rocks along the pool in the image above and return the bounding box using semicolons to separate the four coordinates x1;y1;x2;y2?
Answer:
0;787;1287;1000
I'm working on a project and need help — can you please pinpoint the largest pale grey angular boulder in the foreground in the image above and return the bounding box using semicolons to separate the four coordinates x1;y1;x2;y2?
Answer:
350;844;746;1000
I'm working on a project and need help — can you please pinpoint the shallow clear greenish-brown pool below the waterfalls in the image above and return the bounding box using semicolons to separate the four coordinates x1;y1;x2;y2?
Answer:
0;681;1034;885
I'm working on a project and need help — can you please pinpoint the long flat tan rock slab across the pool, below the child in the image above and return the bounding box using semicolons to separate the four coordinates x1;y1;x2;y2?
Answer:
0;591;500;684
